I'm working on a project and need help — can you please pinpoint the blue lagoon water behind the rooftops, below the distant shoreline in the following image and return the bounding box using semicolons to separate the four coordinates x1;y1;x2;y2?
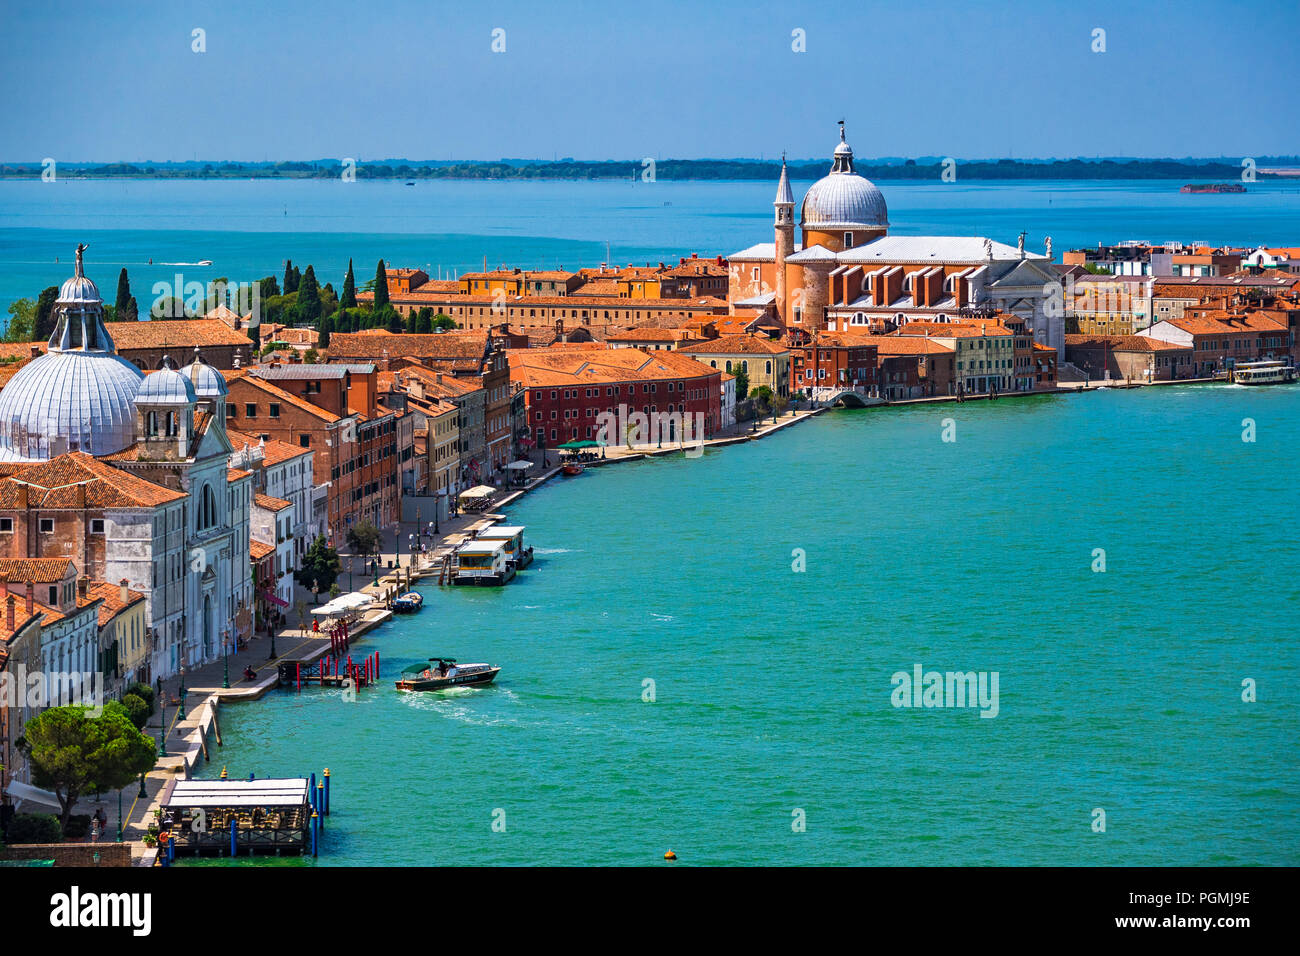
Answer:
0;179;1300;312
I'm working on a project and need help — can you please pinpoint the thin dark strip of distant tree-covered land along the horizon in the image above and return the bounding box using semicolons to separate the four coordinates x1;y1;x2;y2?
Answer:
0;156;1300;182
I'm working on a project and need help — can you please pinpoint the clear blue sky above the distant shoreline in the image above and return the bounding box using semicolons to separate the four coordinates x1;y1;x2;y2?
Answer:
0;0;1300;163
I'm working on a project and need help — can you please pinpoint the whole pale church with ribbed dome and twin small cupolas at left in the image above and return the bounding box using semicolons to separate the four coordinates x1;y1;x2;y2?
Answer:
0;247;254;680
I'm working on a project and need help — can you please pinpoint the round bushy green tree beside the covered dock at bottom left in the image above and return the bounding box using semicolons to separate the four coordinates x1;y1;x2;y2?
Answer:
18;701;156;827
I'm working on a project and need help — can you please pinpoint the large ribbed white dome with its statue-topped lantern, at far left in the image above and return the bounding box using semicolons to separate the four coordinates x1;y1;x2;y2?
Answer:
0;246;143;462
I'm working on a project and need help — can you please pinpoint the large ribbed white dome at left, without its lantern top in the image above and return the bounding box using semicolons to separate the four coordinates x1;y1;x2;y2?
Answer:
0;350;143;462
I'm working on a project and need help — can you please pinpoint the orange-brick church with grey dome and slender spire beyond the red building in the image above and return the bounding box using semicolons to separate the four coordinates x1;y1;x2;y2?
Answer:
728;124;1065;352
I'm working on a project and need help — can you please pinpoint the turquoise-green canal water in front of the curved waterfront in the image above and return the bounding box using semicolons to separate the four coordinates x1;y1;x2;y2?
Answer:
192;386;1300;865
